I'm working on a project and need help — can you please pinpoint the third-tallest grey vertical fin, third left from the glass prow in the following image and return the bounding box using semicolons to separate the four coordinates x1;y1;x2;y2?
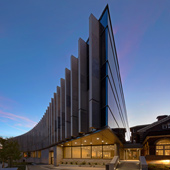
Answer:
71;56;78;136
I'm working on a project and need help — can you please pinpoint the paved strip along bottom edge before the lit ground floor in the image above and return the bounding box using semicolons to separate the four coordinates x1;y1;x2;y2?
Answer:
28;165;105;170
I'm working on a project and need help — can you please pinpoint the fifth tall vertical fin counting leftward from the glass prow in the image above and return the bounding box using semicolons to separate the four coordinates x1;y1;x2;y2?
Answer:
60;79;65;141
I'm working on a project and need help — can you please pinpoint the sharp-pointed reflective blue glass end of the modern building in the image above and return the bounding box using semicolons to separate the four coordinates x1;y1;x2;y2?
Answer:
99;8;130;138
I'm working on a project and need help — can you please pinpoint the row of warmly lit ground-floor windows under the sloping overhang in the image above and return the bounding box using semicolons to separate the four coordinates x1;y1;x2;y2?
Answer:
63;145;114;159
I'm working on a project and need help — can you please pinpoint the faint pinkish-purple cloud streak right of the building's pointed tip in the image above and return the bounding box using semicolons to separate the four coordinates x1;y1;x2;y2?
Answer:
115;2;164;80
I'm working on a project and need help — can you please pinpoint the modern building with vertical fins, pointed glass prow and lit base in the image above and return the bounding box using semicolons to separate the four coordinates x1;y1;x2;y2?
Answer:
15;6;130;165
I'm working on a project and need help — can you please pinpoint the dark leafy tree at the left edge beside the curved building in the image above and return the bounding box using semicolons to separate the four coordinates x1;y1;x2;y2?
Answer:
0;137;22;167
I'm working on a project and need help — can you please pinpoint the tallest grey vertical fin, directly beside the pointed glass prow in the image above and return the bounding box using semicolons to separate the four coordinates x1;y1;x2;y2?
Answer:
89;14;101;128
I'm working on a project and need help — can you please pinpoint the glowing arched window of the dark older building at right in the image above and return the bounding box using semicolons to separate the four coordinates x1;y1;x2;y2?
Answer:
156;139;170;155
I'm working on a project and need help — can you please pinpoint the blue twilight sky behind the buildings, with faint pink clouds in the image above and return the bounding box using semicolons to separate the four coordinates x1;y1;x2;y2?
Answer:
0;0;170;137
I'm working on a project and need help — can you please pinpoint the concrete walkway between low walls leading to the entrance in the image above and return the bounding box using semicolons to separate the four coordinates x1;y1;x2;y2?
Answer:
116;161;140;170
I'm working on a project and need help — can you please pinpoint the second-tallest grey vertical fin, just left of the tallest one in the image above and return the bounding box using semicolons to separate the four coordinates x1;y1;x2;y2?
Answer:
78;38;89;133
